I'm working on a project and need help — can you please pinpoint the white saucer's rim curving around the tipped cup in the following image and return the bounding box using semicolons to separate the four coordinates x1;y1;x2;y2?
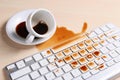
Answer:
6;9;53;45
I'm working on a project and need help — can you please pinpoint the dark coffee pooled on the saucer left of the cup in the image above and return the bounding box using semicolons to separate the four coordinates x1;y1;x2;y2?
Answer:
16;22;28;38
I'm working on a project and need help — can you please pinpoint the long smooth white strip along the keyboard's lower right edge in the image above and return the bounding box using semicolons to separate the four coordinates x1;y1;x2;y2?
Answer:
87;62;120;80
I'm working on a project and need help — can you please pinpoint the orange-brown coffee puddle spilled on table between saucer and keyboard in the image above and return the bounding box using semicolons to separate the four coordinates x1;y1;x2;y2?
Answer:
36;22;87;50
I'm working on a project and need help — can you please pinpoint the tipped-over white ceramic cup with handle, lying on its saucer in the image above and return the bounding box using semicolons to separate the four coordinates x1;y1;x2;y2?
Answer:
25;9;56;43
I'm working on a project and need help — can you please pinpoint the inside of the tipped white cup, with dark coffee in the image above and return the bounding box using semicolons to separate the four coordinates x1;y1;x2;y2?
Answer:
31;10;55;35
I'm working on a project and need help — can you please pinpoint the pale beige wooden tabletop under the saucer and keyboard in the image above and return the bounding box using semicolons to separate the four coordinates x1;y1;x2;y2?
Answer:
0;0;120;80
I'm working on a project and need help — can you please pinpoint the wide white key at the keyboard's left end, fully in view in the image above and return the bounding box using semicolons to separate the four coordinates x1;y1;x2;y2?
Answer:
10;67;31;79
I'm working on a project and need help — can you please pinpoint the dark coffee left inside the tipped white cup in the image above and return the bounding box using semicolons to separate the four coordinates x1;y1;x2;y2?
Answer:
33;21;48;34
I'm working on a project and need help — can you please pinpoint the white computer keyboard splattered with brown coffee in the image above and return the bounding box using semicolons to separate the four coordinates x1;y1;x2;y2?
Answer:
5;24;120;80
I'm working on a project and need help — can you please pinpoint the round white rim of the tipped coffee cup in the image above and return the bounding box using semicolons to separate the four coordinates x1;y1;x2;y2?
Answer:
26;8;56;37
